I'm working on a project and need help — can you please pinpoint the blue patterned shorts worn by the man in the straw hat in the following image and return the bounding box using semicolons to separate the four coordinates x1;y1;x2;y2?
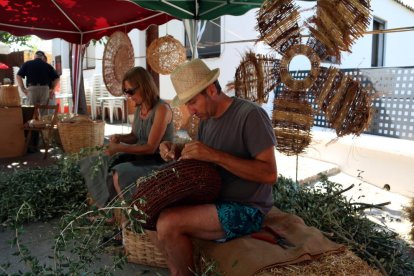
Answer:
216;202;264;241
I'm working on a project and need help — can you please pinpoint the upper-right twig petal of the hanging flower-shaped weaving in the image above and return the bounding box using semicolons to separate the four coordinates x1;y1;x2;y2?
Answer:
308;0;370;61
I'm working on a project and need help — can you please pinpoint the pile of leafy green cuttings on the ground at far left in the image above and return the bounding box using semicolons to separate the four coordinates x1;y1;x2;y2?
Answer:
0;151;86;225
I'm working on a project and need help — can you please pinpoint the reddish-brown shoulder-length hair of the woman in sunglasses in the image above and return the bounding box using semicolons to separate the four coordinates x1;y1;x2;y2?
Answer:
122;66;160;108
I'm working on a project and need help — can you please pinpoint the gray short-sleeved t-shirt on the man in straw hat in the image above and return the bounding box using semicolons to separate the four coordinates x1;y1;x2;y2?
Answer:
198;98;276;214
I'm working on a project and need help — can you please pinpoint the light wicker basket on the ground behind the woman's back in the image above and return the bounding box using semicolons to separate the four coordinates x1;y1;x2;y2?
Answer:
58;116;105;153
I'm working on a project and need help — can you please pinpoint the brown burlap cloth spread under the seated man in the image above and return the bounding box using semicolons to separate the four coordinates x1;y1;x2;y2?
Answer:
194;207;346;275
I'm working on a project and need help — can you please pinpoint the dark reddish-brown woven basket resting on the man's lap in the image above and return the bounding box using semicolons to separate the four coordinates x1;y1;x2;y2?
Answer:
133;160;221;230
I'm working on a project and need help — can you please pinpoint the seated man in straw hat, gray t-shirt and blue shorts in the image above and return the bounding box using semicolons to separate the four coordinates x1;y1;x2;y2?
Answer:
151;59;277;275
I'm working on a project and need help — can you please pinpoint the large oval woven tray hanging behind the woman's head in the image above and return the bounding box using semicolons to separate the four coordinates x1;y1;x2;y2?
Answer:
102;32;135;96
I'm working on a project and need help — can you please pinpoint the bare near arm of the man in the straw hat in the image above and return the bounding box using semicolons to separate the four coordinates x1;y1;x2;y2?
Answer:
181;141;277;185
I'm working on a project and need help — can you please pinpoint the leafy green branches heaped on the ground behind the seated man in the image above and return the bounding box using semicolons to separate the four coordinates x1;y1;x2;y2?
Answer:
274;175;414;275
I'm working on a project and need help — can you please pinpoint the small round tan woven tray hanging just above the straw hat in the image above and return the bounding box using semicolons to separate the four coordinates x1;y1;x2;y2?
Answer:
147;35;187;75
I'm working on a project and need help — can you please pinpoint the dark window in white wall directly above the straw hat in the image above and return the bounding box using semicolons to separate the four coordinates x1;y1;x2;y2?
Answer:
185;17;221;58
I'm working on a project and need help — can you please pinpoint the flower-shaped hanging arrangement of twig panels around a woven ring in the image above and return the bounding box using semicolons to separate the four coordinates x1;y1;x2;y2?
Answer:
249;0;372;155
